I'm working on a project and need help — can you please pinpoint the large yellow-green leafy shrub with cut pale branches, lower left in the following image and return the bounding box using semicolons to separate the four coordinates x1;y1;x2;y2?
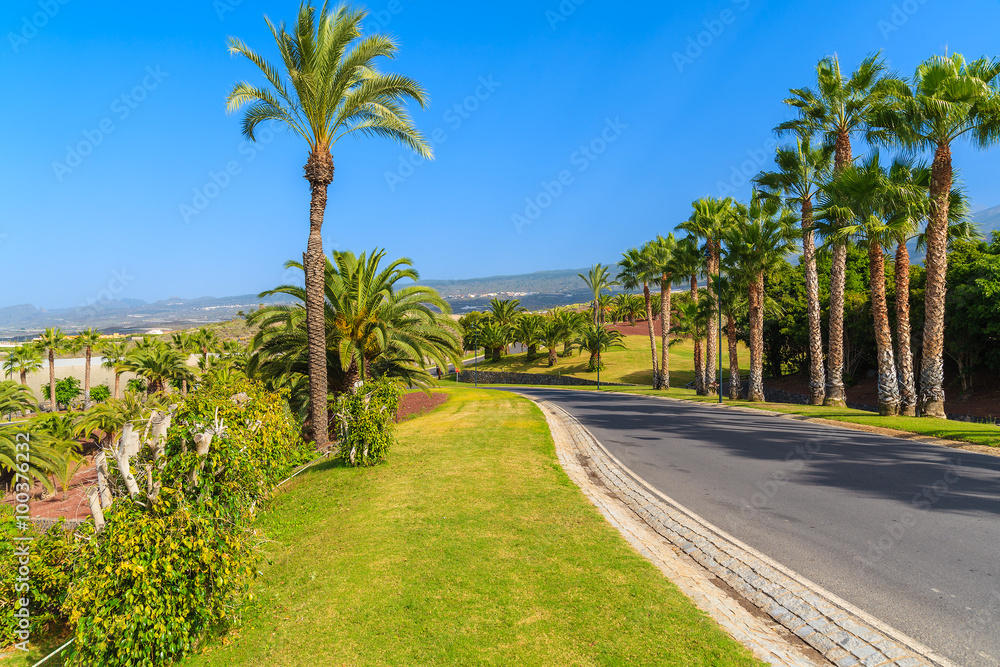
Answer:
65;379;312;665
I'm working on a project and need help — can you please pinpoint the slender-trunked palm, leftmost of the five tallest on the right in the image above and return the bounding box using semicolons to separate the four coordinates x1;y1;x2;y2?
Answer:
755;134;833;405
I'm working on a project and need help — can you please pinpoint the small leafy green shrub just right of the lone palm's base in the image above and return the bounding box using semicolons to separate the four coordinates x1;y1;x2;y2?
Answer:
332;378;399;466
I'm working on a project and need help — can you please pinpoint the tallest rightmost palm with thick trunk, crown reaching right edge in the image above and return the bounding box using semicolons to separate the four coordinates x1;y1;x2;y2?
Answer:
869;53;1000;418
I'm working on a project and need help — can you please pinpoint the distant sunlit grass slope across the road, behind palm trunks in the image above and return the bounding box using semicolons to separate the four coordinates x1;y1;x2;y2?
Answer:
479;336;750;387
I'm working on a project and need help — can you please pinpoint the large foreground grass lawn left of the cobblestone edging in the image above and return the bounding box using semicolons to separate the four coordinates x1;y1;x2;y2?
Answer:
184;389;762;667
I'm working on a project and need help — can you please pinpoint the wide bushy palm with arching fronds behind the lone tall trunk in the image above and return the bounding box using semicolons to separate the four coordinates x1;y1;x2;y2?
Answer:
247;249;458;415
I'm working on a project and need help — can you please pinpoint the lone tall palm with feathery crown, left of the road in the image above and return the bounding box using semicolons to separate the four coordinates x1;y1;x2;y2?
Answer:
227;2;433;447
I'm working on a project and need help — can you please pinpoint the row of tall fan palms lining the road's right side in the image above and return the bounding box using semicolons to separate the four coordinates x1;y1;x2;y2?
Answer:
616;54;1000;417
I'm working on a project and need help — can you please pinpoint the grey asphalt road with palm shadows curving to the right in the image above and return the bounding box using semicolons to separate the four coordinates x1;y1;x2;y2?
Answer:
508;388;1000;667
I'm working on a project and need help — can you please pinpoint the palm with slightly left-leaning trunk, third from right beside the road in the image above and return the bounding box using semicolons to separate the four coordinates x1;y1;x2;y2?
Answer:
822;151;923;415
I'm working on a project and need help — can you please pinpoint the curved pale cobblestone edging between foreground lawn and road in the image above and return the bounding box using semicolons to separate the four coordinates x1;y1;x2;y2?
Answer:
537;401;957;667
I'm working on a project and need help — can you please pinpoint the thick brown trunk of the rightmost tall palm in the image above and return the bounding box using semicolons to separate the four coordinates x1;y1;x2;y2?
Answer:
920;144;952;419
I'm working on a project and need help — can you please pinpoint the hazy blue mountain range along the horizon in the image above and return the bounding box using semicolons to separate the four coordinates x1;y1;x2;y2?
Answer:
0;206;1000;338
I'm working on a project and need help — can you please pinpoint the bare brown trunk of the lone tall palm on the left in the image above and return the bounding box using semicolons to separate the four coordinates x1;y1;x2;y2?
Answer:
303;145;333;447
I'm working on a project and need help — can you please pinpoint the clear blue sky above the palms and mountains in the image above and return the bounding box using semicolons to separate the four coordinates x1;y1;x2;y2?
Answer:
0;0;1000;307
